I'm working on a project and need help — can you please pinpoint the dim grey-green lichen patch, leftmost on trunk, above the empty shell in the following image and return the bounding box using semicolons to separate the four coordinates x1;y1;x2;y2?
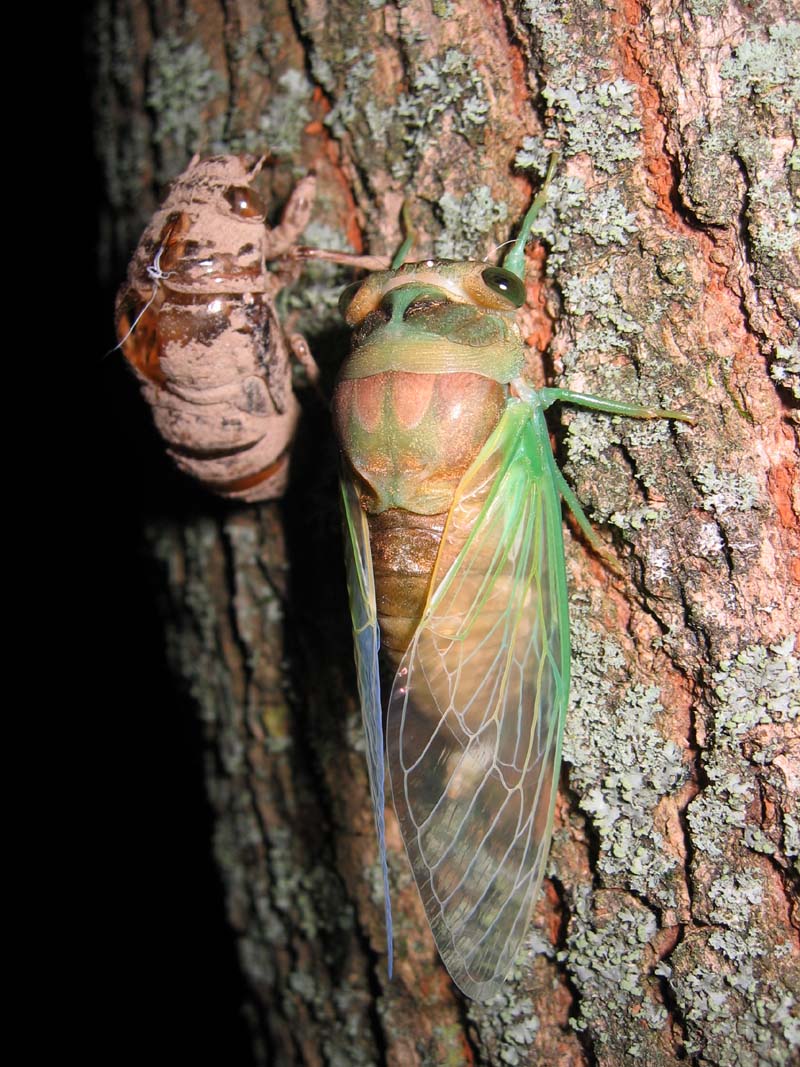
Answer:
147;31;225;179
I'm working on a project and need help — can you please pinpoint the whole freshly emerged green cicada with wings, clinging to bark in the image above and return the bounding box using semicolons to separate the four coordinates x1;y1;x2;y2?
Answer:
334;155;691;1001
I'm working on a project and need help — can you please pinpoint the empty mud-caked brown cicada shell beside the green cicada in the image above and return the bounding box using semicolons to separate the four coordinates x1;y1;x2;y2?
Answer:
116;156;315;500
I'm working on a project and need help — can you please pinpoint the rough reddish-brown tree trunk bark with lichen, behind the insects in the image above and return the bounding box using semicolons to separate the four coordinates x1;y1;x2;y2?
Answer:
95;0;800;1067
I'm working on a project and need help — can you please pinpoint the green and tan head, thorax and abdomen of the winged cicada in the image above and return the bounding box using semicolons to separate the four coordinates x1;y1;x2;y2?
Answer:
333;260;524;666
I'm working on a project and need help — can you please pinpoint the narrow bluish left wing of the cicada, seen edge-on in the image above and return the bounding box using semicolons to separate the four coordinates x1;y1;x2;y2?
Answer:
340;475;391;977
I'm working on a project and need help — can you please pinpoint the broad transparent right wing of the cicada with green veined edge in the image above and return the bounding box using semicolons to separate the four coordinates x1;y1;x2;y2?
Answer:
387;400;570;1000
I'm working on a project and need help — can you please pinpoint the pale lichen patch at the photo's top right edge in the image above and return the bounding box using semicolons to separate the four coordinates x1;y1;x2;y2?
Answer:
720;22;800;115
